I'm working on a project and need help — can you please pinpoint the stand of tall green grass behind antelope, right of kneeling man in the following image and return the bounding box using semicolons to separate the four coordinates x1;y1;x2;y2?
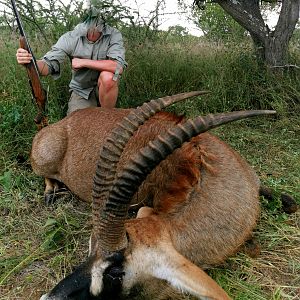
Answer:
120;41;300;114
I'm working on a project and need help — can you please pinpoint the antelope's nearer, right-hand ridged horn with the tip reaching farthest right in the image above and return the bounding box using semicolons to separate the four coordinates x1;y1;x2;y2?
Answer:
97;110;276;252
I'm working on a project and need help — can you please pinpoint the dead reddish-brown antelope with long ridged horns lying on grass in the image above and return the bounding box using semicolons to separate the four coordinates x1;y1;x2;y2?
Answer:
32;92;274;300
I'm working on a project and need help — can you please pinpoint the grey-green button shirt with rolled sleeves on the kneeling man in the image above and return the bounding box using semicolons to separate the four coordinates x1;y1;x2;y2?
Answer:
43;23;127;99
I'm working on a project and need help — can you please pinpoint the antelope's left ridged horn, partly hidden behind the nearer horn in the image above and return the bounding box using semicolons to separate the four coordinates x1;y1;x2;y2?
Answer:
92;91;209;249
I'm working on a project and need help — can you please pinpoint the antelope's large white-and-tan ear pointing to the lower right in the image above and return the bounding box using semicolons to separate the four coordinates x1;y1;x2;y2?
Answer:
146;247;230;300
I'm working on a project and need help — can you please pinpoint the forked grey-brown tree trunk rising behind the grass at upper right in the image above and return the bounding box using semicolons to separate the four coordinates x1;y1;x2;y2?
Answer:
216;0;300;66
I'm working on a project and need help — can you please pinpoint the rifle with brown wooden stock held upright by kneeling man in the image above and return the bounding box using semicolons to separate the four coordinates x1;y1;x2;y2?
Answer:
11;0;48;130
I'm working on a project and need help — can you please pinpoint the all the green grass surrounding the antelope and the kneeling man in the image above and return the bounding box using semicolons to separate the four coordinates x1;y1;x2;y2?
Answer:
0;34;300;300
